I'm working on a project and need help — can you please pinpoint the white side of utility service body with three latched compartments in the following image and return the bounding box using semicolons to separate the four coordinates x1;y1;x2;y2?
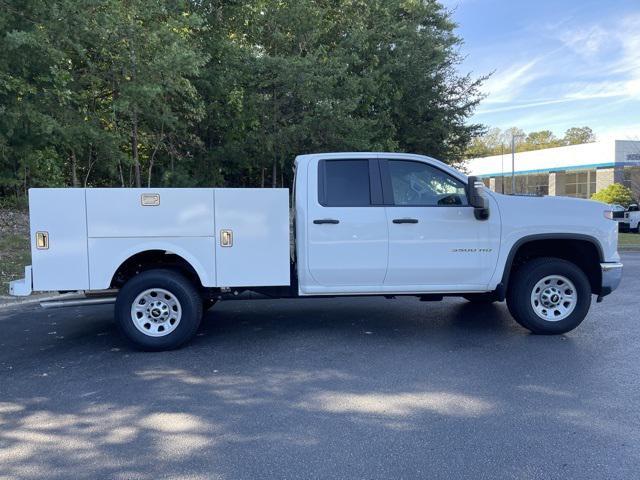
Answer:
29;188;290;291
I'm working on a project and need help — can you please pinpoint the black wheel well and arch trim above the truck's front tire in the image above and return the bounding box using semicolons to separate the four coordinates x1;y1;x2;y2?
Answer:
503;238;602;295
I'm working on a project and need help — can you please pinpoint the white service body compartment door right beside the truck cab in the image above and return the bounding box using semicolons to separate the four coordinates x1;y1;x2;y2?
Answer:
214;188;290;287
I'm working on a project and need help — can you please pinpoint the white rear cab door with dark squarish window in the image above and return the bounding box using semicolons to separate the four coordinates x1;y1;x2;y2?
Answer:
306;158;389;293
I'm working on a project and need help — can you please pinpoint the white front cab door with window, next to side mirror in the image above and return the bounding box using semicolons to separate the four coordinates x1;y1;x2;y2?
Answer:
380;159;500;292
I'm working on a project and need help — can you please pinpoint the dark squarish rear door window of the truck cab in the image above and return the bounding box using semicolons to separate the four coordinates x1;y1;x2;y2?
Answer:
319;160;371;207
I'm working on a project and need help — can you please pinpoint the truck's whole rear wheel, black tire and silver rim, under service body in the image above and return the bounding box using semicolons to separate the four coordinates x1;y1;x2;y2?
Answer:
115;269;202;350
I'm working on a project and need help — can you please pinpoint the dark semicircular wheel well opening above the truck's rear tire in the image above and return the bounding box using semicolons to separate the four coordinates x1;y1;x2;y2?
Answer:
111;250;202;288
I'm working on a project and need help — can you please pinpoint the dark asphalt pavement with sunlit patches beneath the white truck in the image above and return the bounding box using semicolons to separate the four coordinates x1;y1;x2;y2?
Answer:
0;254;640;479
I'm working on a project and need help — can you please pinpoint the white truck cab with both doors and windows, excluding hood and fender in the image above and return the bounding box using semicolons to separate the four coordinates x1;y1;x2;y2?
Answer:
295;153;501;295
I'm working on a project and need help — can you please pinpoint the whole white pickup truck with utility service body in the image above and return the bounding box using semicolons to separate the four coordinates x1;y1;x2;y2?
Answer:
10;153;622;350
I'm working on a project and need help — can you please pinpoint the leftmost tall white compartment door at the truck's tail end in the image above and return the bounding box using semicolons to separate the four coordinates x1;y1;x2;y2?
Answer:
29;188;89;291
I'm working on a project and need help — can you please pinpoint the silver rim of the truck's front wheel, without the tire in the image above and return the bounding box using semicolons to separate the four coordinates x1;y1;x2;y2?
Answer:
531;275;578;322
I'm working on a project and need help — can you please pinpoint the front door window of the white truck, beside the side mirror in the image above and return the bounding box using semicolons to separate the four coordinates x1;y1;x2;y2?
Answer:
388;160;467;207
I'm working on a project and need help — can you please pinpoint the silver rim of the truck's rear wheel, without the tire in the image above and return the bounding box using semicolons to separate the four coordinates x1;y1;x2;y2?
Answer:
131;288;182;337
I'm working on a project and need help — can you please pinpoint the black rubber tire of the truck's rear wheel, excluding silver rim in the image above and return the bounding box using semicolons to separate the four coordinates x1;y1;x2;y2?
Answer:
115;269;202;351
